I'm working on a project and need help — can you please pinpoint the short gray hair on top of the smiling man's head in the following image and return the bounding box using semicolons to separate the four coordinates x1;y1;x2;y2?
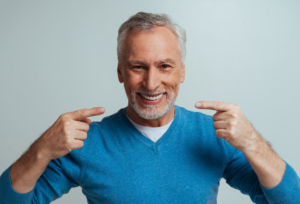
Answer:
117;12;186;62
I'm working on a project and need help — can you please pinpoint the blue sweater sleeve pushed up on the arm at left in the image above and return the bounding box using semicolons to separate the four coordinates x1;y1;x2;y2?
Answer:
0;123;96;204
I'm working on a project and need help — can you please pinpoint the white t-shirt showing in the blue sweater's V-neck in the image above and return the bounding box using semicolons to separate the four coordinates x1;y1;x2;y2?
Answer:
126;115;174;142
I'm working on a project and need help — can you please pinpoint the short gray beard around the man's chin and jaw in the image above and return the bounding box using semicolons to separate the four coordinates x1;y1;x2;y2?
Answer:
130;92;176;120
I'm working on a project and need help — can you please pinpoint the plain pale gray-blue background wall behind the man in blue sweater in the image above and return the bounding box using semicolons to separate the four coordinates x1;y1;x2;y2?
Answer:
0;0;300;204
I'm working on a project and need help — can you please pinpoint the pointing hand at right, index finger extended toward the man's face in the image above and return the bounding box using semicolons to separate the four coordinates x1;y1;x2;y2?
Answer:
195;101;261;151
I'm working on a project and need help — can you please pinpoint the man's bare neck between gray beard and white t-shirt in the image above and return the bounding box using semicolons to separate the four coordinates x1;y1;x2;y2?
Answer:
126;104;175;127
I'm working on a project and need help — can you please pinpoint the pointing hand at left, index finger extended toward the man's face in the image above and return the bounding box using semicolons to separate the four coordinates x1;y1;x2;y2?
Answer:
33;108;105;162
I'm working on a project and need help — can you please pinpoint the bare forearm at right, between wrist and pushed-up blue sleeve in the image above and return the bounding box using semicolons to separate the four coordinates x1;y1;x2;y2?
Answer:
242;133;286;188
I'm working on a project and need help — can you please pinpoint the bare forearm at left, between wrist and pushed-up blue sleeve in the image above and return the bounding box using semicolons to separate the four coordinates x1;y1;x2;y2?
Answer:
10;143;50;193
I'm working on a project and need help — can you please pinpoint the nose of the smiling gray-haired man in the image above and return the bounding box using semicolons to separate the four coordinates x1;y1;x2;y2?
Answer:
144;66;161;91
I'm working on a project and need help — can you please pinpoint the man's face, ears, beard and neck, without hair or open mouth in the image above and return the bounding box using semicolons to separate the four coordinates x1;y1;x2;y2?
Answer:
118;26;185;126
